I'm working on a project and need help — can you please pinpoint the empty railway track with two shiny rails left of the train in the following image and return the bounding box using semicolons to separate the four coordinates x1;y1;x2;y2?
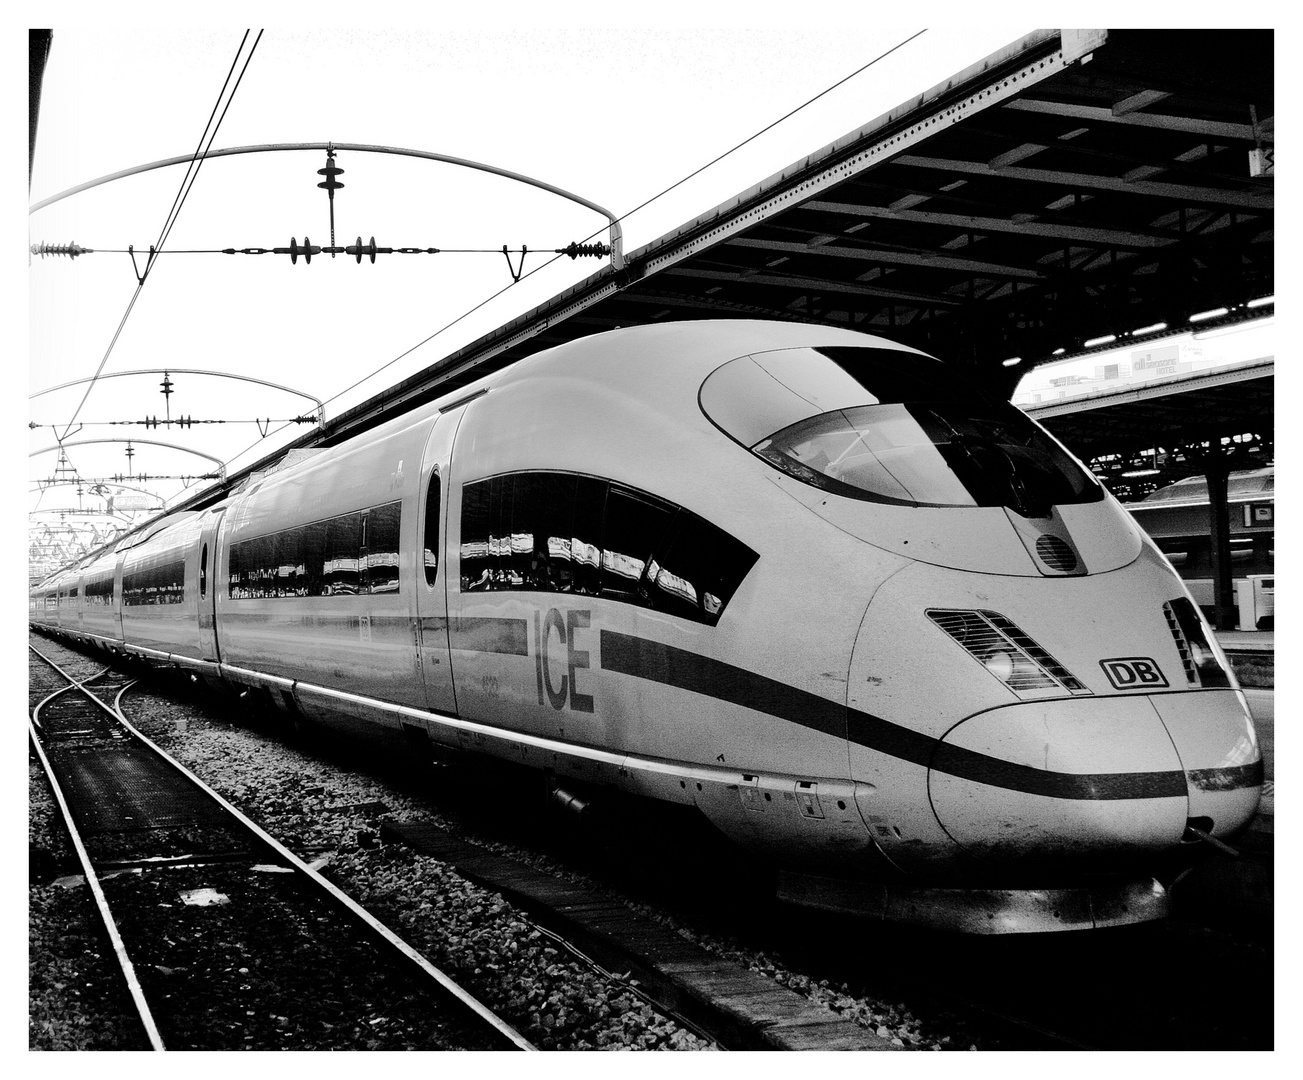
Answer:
30;646;534;1050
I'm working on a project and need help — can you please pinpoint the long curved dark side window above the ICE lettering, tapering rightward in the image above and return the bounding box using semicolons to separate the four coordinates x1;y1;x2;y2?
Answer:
461;473;757;625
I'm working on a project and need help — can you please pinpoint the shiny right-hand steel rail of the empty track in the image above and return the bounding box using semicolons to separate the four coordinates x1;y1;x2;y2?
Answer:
27;635;538;1050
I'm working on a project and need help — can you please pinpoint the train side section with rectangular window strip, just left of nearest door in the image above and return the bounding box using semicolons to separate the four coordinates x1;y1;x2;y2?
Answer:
216;403;429;722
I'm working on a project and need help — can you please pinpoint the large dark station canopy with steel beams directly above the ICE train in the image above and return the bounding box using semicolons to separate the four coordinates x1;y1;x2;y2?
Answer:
213;30;1274;489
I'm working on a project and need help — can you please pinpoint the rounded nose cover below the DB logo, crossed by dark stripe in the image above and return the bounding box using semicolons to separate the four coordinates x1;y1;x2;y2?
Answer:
928;696;1188;864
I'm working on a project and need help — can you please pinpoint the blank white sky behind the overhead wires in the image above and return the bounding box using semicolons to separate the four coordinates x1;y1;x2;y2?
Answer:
27;15;1025;534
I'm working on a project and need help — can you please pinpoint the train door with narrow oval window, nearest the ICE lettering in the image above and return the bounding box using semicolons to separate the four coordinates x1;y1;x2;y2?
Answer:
416;406;463;715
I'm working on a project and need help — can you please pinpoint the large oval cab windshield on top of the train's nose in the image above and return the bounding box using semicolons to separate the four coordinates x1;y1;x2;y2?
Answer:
701;347;1104;517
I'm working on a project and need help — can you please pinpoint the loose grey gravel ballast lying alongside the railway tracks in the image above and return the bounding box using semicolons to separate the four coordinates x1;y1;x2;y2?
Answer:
30;635;971;1050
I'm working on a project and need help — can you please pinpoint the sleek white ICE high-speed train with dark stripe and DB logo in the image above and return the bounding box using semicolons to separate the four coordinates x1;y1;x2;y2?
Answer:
31;320;1263;933
